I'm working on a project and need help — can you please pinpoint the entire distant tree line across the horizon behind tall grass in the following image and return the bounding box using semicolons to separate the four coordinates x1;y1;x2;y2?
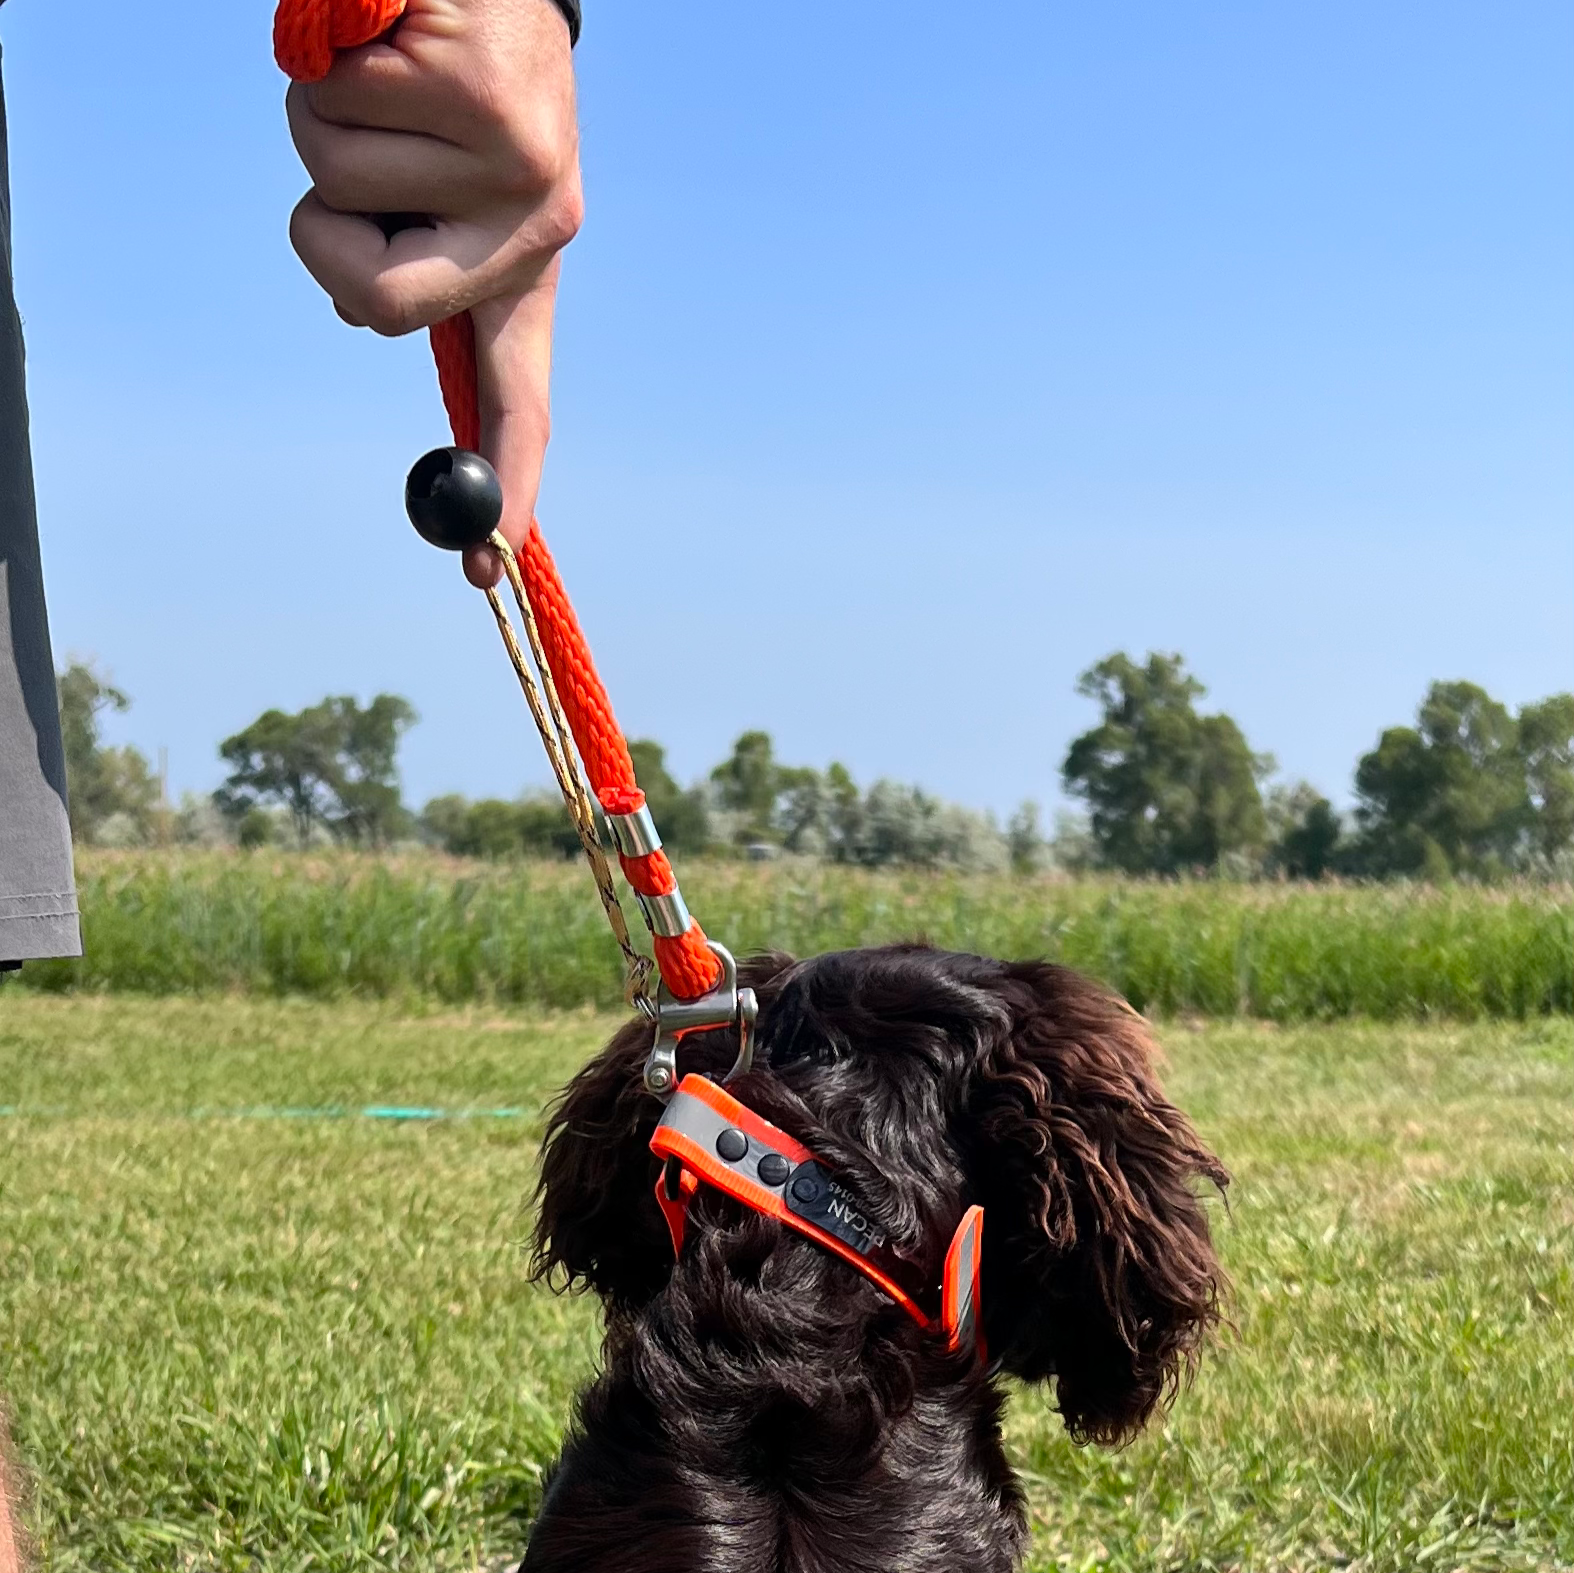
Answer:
60;653;1574;880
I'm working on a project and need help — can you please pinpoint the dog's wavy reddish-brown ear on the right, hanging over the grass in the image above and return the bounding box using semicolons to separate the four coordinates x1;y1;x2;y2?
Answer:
966;964;1229;1442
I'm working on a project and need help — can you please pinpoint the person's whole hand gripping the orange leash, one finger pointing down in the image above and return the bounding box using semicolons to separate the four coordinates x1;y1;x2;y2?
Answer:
285;0;582;587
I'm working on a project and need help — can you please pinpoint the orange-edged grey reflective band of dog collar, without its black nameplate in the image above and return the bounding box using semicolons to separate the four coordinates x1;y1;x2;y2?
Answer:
650;1075;984;1356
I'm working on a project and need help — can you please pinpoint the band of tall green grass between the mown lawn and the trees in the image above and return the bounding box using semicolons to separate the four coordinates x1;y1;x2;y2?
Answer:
24;853;1574;1022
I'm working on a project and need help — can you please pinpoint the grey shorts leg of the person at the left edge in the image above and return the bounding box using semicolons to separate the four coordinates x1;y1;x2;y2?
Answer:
0;46;82;964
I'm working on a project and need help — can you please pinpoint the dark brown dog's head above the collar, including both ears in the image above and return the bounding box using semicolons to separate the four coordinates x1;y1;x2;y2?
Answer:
537;945;1228;1442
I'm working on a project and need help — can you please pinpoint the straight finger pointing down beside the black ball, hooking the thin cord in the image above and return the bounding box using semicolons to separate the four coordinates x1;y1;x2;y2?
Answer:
464;258;557;589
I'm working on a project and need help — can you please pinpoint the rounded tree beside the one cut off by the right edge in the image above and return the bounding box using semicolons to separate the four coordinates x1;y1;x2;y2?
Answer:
1355;682;1530;879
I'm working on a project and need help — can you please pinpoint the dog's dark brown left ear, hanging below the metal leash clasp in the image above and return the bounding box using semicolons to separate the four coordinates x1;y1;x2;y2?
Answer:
532;954;792;1312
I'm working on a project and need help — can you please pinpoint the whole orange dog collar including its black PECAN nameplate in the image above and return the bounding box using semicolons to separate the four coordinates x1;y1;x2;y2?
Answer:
650;1075;984;1359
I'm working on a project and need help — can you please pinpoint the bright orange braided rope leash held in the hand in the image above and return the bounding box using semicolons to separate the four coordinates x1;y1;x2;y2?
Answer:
274;0;722;1000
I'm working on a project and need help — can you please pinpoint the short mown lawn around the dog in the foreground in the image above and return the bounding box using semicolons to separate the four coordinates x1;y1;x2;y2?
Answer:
0;990;1574;1573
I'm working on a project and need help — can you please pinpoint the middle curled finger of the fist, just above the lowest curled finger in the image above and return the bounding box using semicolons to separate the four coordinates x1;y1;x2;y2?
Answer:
285;91;496;217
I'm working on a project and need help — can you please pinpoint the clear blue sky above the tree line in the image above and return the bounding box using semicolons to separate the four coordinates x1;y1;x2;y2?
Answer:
0;0;1574;811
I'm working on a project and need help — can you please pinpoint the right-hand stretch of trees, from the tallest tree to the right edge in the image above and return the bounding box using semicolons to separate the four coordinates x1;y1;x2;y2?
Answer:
1062;655;1574;880
